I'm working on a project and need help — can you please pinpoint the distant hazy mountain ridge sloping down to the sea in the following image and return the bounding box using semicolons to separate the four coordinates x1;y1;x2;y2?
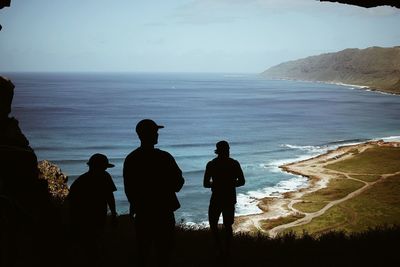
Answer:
261;46;400;94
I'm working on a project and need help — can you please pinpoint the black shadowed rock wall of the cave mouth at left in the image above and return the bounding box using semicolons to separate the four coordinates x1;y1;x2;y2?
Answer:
0;76;51;218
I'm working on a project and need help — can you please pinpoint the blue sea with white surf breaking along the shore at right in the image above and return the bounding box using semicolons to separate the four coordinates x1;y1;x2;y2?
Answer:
7;73;400;223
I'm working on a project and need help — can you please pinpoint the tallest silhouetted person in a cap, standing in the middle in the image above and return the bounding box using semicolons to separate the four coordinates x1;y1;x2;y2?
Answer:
124;119;184;266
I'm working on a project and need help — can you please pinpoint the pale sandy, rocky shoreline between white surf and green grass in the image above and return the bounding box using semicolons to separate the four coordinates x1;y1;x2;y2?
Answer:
234;140;400;236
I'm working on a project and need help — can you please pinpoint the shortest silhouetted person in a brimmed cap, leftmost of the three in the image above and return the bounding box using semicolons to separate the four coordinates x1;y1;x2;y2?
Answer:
67;154;117;266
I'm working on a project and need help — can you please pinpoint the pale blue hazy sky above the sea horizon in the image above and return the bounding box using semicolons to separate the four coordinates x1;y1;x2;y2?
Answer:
0;0;400;73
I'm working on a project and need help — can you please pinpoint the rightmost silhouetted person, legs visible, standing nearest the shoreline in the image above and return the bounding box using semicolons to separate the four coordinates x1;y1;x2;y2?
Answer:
203;141;245;253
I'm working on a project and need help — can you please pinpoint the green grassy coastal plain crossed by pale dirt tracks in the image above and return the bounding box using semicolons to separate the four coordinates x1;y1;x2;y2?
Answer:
285;146;400;237
